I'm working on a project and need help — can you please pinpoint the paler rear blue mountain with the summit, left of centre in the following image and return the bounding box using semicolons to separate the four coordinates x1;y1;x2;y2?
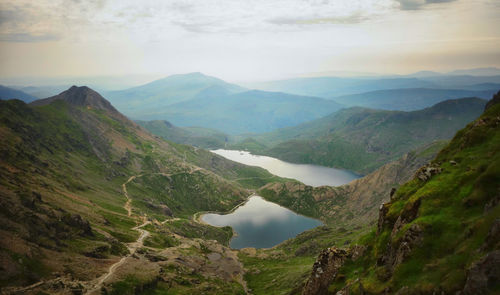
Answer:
105;73;245;119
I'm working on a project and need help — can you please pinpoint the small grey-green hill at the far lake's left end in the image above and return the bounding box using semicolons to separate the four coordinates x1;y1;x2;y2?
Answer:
136;120;228;149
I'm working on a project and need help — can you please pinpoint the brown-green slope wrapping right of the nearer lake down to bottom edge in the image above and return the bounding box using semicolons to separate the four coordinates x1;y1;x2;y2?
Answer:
239;142;447;294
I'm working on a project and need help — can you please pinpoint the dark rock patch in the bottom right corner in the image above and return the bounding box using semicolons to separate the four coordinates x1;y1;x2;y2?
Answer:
462;250;500;295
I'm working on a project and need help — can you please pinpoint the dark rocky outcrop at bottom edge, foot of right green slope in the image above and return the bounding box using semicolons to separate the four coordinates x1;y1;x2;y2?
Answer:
302;247;349;295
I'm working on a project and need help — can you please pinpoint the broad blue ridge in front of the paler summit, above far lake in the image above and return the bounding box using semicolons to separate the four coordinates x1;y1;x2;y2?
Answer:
157;90;342;134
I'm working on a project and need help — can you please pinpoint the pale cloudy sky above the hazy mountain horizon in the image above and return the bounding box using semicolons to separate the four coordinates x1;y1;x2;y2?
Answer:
0;0;500;82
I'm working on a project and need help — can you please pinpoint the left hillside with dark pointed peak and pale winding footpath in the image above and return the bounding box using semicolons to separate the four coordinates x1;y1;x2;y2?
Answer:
0;86;277;294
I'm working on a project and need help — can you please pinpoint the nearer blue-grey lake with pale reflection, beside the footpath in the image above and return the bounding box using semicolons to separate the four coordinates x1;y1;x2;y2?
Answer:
201;196;322;249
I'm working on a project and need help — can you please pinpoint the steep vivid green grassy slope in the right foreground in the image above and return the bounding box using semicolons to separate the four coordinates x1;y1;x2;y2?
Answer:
320;96;500;294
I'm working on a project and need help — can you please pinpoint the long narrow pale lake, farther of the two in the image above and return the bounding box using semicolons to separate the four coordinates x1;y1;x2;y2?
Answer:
212;149;361;186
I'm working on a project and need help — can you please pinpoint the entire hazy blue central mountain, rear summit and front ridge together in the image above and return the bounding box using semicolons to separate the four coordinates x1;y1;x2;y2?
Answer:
107;73;342;134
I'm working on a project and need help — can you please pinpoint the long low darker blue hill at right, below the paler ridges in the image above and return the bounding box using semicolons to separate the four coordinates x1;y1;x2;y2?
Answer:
332;88;500;111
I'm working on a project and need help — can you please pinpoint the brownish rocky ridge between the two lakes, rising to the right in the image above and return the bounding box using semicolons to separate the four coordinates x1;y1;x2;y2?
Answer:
259;141;446;227
